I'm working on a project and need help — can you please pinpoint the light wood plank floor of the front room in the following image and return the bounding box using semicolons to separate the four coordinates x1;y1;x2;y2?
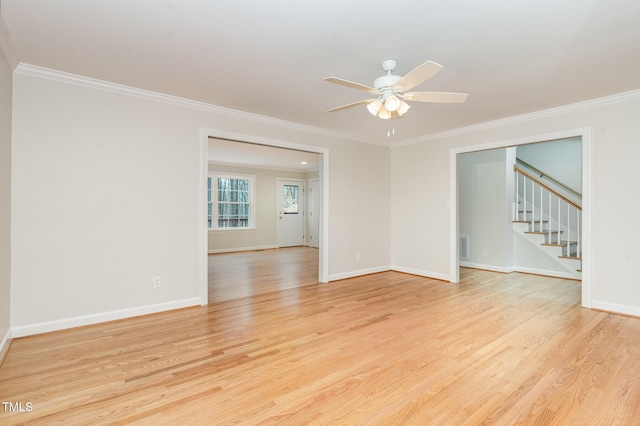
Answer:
0;248;640;425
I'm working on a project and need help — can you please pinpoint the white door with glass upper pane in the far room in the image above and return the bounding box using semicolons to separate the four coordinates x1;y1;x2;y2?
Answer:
277;178;304;247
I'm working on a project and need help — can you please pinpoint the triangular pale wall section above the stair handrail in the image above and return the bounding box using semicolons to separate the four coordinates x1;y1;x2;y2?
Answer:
517;138;582;194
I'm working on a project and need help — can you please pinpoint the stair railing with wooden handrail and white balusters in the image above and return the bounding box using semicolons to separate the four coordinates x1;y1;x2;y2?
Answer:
513;164;582;259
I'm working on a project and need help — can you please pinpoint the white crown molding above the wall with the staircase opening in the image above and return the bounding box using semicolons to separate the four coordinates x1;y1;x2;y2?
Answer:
392;90;640;147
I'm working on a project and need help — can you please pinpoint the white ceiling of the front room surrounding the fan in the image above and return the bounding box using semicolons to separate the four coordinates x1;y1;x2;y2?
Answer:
0;0;640;144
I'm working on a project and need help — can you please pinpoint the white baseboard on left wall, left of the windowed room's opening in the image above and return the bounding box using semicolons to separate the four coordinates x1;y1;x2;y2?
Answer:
11;297;201;338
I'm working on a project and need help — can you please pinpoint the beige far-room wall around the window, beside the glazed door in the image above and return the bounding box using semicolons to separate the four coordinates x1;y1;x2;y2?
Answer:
208;164;306;253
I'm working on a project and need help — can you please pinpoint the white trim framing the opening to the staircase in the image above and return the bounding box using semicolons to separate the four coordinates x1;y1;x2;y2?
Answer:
449;128;592;308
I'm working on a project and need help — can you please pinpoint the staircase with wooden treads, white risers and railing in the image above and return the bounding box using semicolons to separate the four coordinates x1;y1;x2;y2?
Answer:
513;160;582;279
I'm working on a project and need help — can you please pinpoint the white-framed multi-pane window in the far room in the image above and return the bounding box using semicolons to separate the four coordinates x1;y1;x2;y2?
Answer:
207;173;255;230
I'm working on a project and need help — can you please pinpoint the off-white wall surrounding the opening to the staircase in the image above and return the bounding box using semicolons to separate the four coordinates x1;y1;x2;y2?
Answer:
391;92;640;315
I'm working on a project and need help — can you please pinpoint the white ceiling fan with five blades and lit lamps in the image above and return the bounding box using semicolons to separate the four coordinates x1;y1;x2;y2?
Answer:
325;59;469;120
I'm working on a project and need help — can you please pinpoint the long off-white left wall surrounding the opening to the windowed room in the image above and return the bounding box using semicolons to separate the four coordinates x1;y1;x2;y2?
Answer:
11;65;390;335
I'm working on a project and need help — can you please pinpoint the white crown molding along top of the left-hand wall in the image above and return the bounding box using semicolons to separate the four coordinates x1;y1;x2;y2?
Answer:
15;63;387;146
